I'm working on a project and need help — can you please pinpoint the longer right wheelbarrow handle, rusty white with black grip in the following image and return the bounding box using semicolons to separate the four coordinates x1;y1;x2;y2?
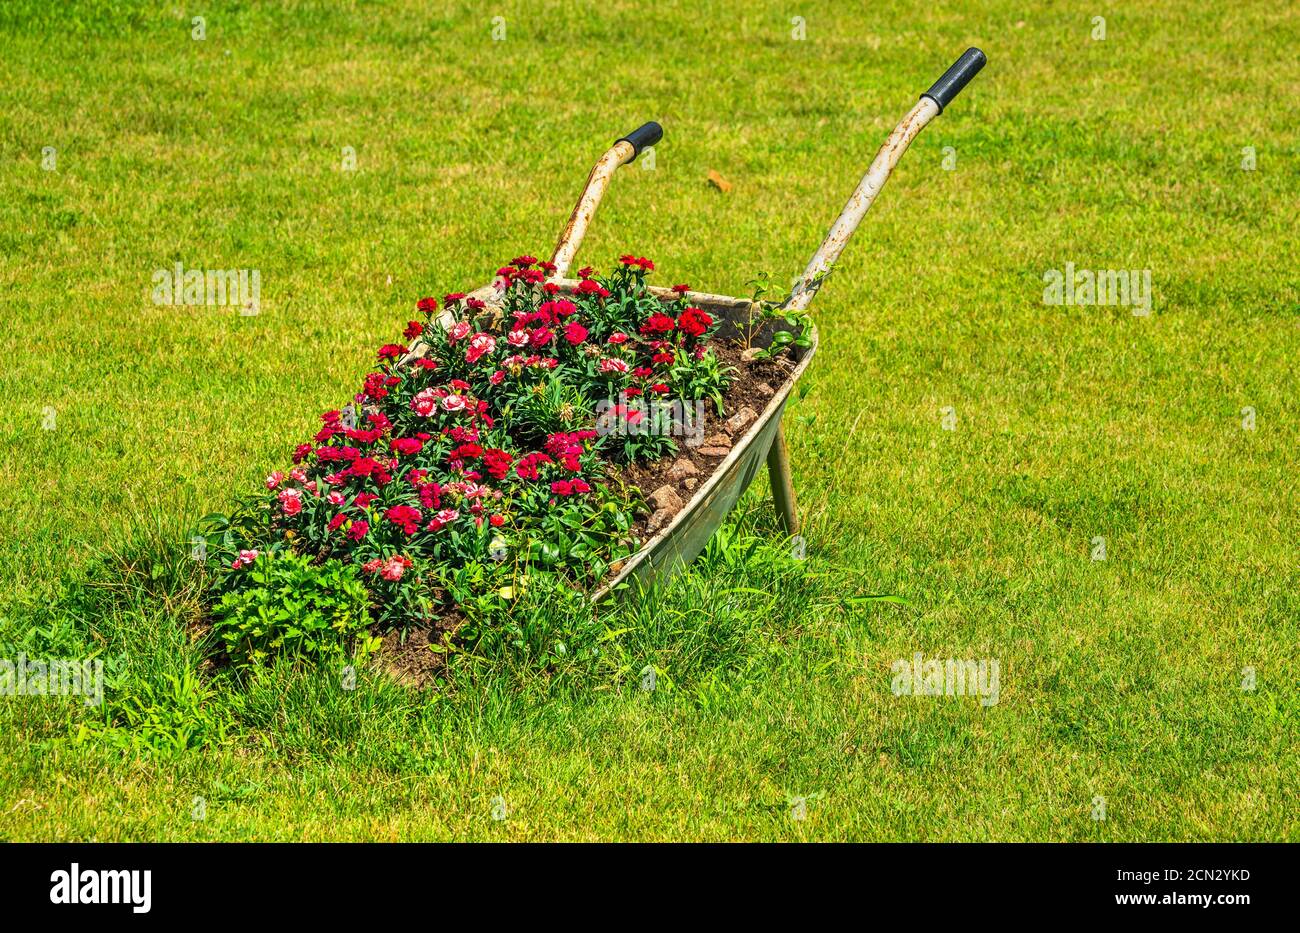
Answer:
784;48;985;311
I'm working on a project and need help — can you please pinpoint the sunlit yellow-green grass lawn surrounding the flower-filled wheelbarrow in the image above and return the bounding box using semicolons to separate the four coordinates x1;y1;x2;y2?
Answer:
0;0;1300;841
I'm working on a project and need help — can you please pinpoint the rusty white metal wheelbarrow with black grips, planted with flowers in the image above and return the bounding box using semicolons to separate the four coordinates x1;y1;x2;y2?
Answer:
431;48;985;602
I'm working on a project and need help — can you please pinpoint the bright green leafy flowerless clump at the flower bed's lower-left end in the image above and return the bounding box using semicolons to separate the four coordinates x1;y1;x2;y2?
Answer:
212;552;374;665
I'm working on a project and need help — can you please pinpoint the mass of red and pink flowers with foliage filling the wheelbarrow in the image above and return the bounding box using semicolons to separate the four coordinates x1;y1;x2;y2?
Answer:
217;256;729;654
